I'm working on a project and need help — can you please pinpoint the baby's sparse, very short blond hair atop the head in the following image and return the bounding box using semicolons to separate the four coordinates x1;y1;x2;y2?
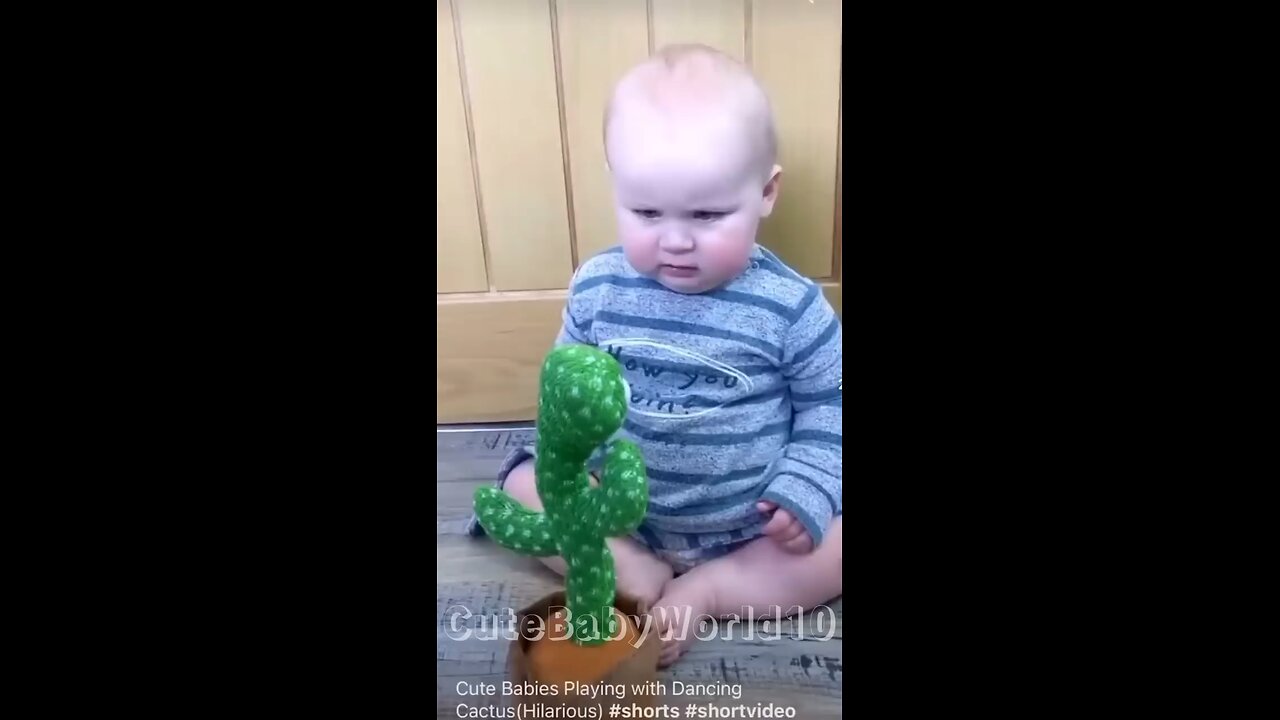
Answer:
602;42;778;178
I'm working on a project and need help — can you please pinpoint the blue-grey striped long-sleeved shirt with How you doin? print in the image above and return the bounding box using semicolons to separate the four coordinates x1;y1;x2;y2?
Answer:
556;246;844;550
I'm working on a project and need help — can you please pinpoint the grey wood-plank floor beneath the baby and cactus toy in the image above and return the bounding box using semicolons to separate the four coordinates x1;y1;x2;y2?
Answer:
435;429;844;719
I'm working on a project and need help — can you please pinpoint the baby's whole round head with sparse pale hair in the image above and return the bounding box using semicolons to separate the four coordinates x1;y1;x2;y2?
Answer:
604;45;781;292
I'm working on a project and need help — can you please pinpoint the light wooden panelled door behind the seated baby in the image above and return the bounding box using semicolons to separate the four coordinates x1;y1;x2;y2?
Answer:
435;0;844;424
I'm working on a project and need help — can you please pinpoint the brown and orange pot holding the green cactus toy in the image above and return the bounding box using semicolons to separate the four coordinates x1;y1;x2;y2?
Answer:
507;591;662;717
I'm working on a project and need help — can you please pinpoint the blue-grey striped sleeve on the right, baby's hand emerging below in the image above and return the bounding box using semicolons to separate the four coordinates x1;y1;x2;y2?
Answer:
762;286;844;546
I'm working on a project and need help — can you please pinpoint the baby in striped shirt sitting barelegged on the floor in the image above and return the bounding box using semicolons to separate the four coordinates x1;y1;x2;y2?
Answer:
472;45;844;665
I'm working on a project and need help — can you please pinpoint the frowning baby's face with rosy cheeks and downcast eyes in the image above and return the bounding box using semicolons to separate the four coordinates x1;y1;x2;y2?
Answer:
609;105;777;293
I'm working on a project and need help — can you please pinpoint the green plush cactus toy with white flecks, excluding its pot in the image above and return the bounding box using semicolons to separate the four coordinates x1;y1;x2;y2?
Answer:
475;345;649;646
